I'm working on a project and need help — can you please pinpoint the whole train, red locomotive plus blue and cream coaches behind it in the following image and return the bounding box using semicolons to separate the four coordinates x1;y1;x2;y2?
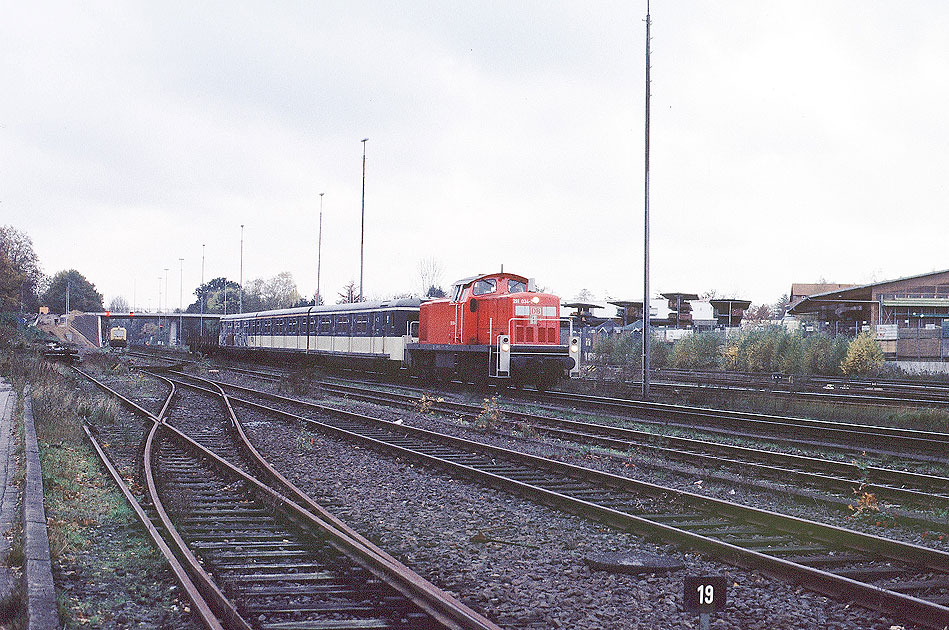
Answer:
218;272;580;389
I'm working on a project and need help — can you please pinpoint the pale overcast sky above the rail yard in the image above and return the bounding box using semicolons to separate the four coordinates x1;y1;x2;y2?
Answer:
0;0;949;314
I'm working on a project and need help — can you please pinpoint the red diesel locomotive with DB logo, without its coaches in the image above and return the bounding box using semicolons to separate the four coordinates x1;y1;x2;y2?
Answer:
407;272;579;388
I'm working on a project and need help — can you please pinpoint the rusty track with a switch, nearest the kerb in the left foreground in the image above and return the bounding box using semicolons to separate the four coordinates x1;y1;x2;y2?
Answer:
75;374;499;630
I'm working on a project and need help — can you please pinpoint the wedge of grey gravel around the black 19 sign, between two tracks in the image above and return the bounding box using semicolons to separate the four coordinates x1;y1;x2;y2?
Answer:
239;400;900;630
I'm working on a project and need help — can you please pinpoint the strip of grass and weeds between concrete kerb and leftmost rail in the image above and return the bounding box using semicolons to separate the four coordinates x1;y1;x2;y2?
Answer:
4;351;195;629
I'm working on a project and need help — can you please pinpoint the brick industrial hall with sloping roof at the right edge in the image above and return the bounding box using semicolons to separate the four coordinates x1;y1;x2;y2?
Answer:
788;269;949;371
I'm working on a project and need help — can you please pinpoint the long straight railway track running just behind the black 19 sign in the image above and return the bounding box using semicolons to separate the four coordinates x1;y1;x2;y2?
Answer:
163;375;949;628
